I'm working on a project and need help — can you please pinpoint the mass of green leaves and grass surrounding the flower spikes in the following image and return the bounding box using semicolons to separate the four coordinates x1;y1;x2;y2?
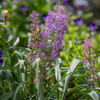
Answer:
0;0;100;100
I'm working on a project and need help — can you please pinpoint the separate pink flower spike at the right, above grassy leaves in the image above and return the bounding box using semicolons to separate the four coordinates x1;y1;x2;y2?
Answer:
82;39;98;87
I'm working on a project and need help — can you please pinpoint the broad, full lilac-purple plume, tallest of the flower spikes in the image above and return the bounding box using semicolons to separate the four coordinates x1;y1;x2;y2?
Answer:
42;5;67;61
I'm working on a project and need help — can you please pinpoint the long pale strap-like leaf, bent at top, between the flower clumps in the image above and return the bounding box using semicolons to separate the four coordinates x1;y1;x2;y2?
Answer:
61;59;80;100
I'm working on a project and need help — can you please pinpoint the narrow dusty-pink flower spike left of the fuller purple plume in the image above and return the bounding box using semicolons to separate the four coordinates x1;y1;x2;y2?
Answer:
28;11;42;63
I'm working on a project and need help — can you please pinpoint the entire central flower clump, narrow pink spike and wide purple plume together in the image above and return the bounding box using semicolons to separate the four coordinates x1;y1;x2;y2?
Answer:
28;5;67;82
